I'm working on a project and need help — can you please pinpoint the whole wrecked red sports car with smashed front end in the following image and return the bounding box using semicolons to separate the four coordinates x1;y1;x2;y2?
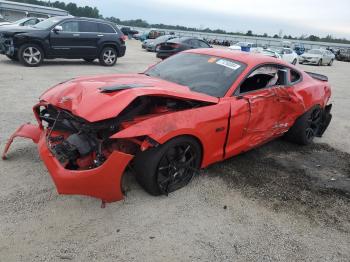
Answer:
3;49;331;205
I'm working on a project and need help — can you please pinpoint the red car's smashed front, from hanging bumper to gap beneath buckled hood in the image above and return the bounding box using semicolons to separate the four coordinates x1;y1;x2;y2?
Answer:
3;96;205;202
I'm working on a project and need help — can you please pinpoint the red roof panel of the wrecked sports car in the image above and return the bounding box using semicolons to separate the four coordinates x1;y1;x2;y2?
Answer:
185;48;291;67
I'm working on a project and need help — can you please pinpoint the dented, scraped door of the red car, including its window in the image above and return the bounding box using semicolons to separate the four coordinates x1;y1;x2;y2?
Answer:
225;65;289;158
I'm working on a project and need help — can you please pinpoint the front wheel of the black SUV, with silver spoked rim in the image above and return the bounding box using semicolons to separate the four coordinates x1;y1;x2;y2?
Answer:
18;44;44;67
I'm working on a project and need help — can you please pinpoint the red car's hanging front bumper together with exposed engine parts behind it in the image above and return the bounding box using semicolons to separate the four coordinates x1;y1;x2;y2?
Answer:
3;103;137;202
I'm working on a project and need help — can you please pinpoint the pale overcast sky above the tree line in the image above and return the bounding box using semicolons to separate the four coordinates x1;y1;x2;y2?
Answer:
58;0;350;39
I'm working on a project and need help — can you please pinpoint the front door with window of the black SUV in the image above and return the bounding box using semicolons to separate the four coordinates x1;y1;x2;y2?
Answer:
50;20;80;57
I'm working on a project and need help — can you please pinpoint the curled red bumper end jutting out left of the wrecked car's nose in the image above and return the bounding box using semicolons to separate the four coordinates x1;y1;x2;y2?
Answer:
2;123;42;160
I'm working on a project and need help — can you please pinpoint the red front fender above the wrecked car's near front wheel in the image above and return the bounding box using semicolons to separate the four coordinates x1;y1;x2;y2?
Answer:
111;103;230;168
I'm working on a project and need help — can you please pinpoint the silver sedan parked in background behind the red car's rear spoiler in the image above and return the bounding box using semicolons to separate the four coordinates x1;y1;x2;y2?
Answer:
299;49;335;66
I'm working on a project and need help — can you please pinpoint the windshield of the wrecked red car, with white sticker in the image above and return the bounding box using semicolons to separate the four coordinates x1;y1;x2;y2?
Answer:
145;53;245;97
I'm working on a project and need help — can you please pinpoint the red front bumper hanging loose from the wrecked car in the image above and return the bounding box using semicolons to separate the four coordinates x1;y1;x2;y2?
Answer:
3;124;133;202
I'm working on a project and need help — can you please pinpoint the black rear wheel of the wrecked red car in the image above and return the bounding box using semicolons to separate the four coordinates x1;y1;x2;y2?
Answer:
285;106;322;145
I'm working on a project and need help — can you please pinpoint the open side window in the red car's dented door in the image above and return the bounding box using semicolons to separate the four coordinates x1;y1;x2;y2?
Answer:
239;65;286;94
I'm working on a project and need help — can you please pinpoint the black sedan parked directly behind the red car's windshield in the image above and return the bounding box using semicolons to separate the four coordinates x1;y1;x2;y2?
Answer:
156;37;211;59
